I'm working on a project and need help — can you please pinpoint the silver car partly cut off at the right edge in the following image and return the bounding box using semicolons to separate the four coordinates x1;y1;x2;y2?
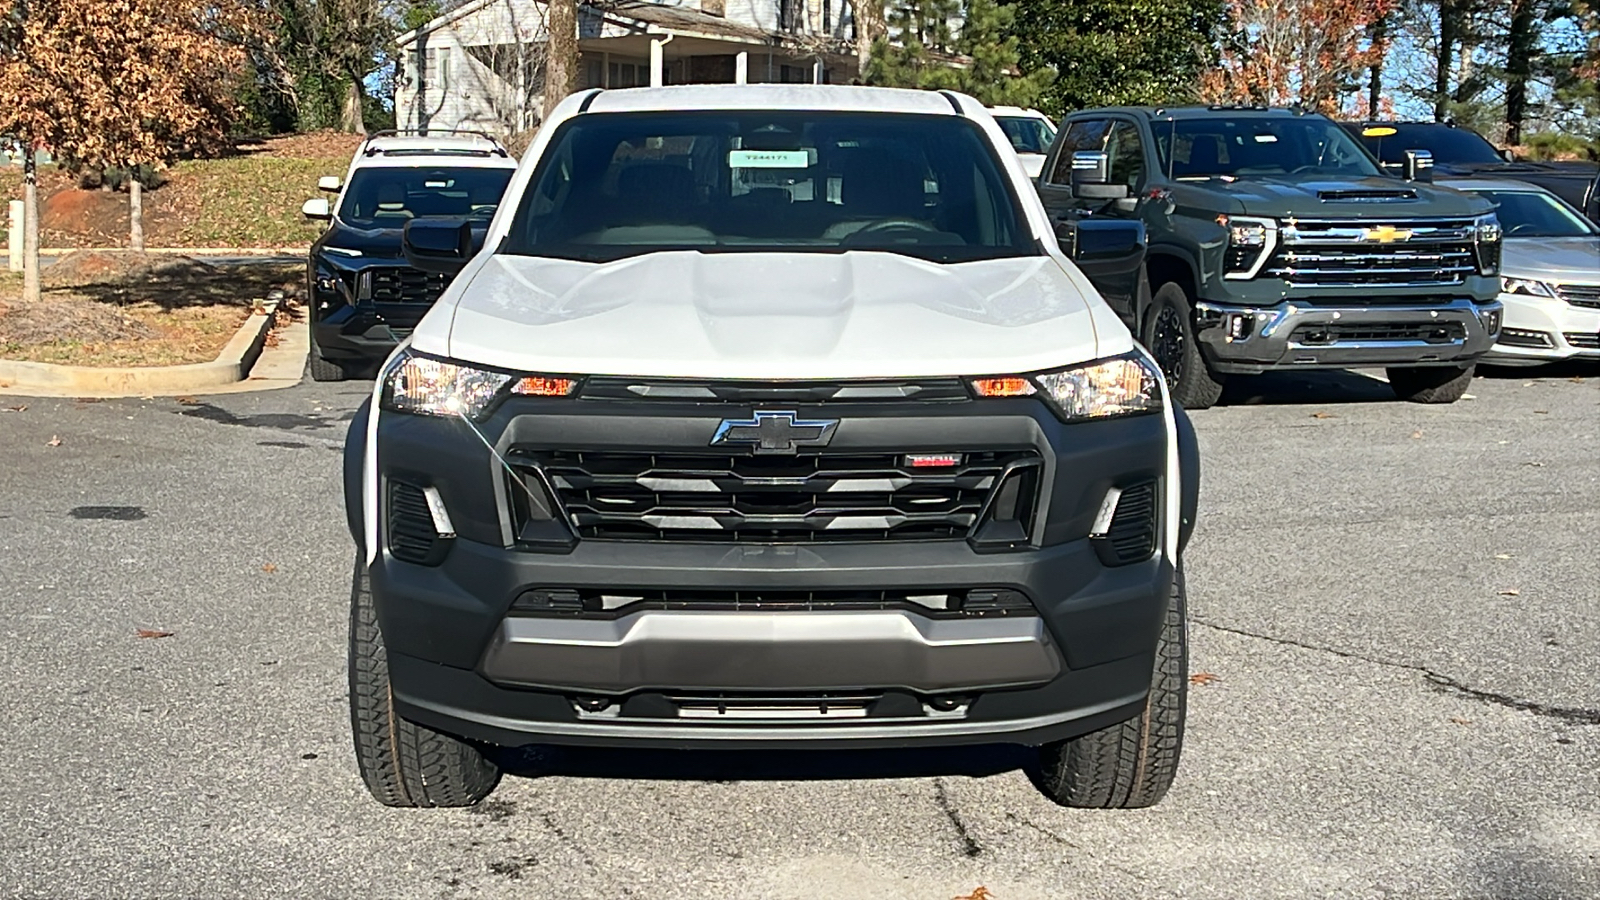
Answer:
1440;179;1600;365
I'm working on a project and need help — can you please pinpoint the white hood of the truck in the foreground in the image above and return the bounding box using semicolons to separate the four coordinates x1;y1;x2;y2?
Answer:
411;251;1113;380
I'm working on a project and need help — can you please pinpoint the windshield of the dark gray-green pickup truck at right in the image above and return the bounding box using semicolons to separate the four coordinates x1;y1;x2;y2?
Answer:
1152;115;1379;181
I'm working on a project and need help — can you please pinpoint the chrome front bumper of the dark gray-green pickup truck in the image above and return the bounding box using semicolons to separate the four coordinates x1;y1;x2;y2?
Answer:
1195;298;1502;375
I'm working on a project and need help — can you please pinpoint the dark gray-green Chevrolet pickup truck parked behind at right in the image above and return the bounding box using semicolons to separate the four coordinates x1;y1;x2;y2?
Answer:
1037;107;1501;408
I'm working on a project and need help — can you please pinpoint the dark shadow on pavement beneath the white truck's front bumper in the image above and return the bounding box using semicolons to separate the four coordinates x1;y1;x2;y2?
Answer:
499;745;1037;781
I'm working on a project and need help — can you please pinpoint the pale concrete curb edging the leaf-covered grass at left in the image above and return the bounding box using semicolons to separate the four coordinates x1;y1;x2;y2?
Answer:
0;301;278;399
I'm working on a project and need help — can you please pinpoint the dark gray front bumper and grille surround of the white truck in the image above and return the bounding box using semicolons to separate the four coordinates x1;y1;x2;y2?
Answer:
360;399;1195;746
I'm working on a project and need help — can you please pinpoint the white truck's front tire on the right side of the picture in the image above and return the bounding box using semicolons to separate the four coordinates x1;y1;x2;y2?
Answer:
1032;565;1189;809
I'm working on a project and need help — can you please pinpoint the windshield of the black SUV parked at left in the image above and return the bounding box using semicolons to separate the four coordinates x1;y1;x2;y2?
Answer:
339;165;515;227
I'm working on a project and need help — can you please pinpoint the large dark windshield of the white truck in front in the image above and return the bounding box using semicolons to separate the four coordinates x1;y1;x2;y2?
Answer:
506;110;1038;263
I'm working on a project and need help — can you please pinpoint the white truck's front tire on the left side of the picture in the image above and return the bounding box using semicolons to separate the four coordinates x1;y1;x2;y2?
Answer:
350;559;499;807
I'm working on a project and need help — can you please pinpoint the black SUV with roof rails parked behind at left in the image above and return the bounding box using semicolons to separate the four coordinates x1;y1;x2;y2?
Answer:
302;131;517;381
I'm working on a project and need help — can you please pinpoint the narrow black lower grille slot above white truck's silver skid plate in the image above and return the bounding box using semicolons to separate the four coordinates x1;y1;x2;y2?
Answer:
510;582;1036;618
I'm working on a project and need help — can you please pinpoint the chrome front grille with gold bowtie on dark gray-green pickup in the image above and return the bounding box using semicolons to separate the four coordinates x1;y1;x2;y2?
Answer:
1262;221;1477;287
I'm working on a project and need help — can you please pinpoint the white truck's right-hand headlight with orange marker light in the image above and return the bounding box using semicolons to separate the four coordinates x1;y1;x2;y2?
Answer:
973;354;1162;421
